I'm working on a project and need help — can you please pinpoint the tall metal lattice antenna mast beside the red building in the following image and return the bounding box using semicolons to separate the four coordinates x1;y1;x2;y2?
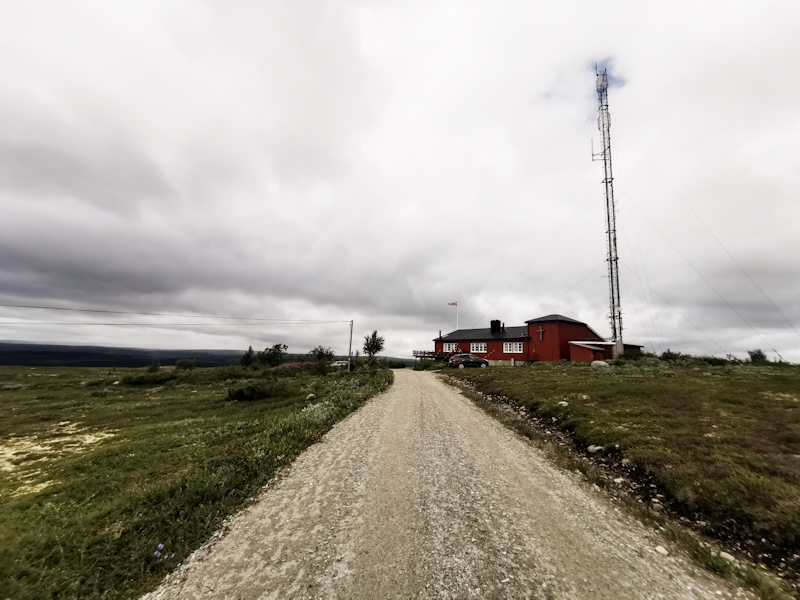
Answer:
592;66;625;358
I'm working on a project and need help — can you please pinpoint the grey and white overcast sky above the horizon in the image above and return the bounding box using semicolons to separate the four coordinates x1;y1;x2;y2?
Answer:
0;0;800;362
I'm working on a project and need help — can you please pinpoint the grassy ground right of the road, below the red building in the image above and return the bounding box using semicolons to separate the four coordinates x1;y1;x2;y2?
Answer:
448;359;800;596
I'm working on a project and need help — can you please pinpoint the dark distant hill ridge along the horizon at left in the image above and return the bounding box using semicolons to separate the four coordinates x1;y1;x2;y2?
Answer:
0;342;416;367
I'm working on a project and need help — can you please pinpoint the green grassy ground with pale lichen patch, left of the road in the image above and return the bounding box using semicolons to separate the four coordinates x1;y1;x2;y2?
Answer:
0;367;392;599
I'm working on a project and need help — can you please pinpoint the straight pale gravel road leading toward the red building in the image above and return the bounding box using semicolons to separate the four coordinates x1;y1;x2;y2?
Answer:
146;371;750;600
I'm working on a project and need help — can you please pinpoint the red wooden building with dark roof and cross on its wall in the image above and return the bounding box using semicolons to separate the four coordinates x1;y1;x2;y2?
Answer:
433;315;642;364
